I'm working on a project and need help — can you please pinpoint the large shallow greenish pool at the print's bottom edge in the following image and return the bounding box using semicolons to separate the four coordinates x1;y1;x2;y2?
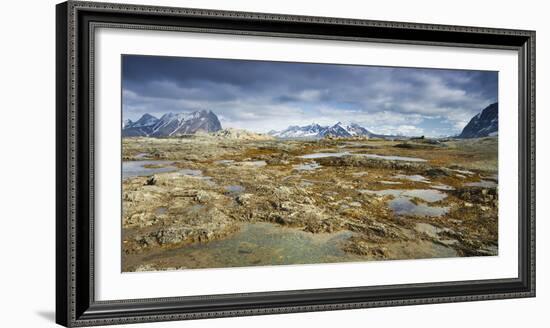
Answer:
134;222;366;268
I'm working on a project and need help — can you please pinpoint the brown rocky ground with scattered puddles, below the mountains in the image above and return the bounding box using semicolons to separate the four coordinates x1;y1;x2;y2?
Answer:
122;135;498;271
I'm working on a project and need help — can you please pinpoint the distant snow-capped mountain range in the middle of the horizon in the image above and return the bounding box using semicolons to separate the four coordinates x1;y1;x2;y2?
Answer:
269;122;374;138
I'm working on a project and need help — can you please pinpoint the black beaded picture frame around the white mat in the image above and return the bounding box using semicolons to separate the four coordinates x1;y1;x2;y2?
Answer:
56;1;535;326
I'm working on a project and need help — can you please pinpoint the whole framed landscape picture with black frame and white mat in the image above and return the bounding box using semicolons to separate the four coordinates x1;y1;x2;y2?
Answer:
56;1;535;326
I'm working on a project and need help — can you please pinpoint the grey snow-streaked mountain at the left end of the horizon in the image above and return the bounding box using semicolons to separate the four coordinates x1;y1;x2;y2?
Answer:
122;110;222;137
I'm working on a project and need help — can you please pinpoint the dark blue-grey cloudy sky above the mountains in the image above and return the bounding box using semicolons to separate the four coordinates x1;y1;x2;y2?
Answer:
122;55;498;136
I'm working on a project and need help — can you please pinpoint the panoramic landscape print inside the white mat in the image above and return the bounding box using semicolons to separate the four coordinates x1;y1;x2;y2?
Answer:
121;55;499;272
